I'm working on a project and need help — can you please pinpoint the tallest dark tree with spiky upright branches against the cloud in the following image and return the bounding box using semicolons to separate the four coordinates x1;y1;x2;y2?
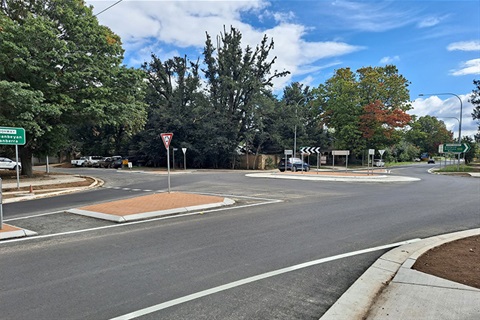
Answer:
204;27;288;167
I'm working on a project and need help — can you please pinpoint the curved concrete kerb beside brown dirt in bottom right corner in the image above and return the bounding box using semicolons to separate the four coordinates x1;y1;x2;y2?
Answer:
320;228;480;320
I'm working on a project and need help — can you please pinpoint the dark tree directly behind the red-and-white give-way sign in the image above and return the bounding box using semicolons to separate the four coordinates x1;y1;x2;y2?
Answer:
136;55;207;167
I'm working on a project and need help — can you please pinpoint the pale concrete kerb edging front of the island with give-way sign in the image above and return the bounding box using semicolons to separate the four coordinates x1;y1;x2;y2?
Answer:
65;198;235;223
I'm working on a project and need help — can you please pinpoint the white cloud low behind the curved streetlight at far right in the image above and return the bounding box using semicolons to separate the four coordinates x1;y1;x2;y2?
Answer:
408;94;478;138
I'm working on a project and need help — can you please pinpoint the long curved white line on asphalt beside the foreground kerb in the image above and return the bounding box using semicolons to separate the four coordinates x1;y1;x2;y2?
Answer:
110;238;421;320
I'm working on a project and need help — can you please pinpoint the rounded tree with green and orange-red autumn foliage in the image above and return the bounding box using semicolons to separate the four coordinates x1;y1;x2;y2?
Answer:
315;65;411;155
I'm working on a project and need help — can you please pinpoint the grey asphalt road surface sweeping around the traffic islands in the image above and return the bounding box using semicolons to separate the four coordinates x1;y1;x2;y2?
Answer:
0;164;480;319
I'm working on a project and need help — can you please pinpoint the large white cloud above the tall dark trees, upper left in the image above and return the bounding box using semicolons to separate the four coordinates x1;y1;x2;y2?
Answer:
87;0;364;89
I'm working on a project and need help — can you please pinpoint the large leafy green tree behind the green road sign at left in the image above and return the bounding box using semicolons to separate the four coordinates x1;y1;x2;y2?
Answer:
0;0;144;175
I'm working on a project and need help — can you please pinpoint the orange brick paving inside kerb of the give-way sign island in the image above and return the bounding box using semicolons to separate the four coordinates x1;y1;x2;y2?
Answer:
78;192;224;216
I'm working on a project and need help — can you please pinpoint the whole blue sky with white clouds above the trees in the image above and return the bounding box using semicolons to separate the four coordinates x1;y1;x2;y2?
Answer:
86;0;480;137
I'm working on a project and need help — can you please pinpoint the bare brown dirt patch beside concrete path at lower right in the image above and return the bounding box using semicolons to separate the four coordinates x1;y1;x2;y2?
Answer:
412;235;480;289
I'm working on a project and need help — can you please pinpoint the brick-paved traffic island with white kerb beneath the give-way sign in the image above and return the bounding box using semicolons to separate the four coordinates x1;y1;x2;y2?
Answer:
66;192;235;223
